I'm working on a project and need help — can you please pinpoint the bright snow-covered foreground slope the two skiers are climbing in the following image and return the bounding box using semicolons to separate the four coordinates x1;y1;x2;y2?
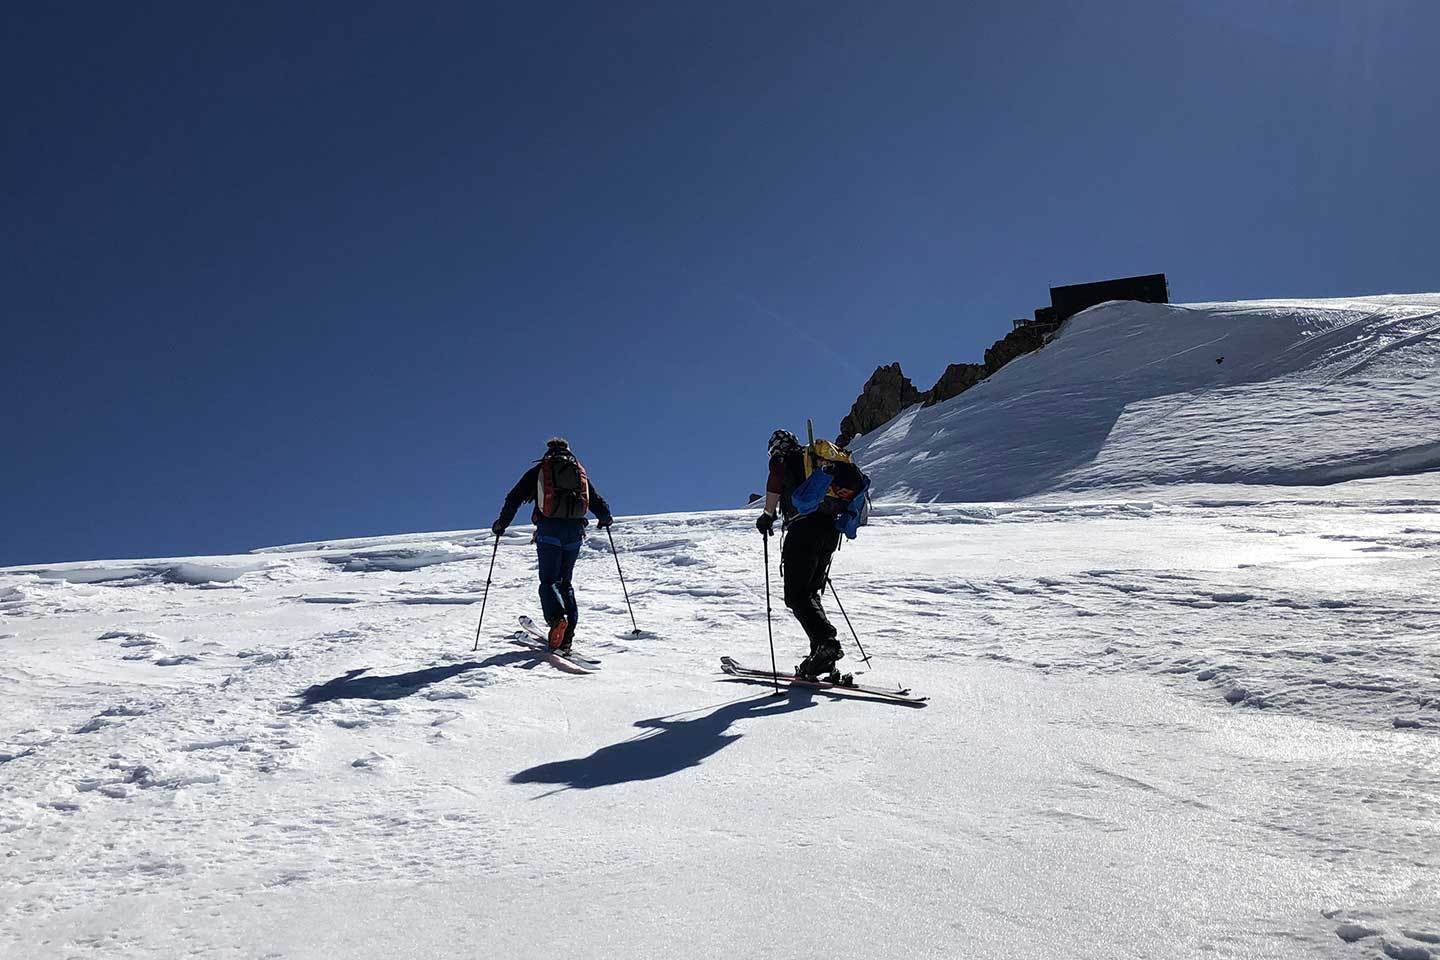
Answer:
0;476;1440;960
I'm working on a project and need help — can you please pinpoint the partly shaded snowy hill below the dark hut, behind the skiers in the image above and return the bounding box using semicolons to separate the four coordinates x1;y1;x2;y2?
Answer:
854;294;1440;502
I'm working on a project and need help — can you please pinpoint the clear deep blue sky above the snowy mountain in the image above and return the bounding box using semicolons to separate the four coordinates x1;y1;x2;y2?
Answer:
0;0;1440;564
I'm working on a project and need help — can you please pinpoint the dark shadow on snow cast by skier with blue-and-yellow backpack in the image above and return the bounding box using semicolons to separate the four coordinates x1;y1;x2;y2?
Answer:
510;697;815;799
